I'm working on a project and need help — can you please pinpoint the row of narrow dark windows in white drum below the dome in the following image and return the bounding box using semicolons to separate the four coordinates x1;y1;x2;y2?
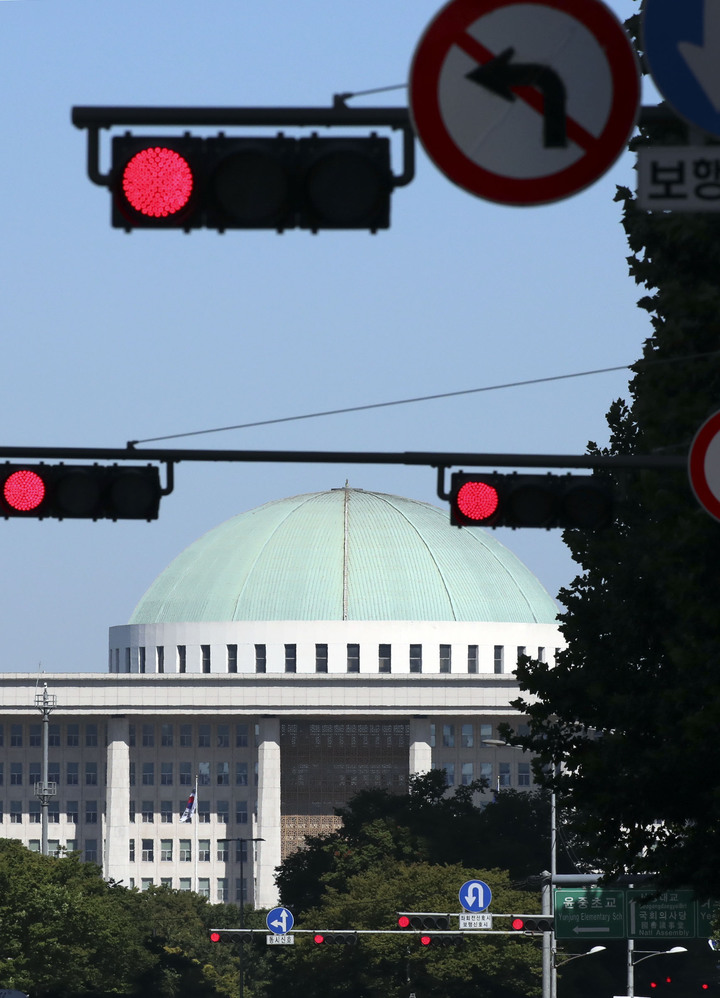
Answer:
110;643;545;673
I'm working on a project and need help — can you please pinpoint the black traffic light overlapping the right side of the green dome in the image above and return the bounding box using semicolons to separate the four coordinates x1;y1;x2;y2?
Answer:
450;472;613;530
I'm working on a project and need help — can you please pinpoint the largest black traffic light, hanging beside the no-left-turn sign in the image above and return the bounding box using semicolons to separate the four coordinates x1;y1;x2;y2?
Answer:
110;133;394;232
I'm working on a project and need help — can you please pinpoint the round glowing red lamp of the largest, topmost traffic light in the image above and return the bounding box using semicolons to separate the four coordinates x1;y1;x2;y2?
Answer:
122;146;193;218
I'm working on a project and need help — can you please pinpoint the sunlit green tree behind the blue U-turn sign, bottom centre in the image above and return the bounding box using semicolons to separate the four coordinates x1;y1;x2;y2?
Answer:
253;856;541;998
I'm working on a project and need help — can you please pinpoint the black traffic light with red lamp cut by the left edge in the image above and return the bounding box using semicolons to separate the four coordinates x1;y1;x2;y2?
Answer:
0;463;162;520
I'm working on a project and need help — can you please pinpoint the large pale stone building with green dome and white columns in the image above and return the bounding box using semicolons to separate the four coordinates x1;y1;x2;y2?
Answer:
0;486;561;907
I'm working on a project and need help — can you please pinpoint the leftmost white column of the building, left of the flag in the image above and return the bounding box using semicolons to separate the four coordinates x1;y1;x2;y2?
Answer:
103;717;130;887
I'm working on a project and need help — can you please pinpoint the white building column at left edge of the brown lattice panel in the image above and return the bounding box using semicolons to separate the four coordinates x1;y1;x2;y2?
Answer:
253;717;282;908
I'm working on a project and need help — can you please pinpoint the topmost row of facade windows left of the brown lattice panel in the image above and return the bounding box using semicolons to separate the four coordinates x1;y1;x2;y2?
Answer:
0;722;258;748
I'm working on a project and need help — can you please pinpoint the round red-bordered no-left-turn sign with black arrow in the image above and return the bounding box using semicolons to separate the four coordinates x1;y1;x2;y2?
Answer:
409;0;640;205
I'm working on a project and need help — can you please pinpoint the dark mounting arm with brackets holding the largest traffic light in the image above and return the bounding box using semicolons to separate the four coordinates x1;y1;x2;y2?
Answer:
72;102;415;187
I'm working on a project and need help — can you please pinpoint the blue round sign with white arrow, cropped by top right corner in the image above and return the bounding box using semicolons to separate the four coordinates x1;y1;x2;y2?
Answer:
642;0;720;135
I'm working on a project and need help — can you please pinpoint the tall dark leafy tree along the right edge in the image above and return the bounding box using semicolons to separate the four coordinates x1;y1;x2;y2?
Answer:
506;60;720;897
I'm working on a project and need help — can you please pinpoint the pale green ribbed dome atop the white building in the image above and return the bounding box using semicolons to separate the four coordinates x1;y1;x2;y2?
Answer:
130;487;557;624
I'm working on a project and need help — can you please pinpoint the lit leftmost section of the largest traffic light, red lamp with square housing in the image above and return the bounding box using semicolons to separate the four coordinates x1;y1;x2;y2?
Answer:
110;132;204;232
